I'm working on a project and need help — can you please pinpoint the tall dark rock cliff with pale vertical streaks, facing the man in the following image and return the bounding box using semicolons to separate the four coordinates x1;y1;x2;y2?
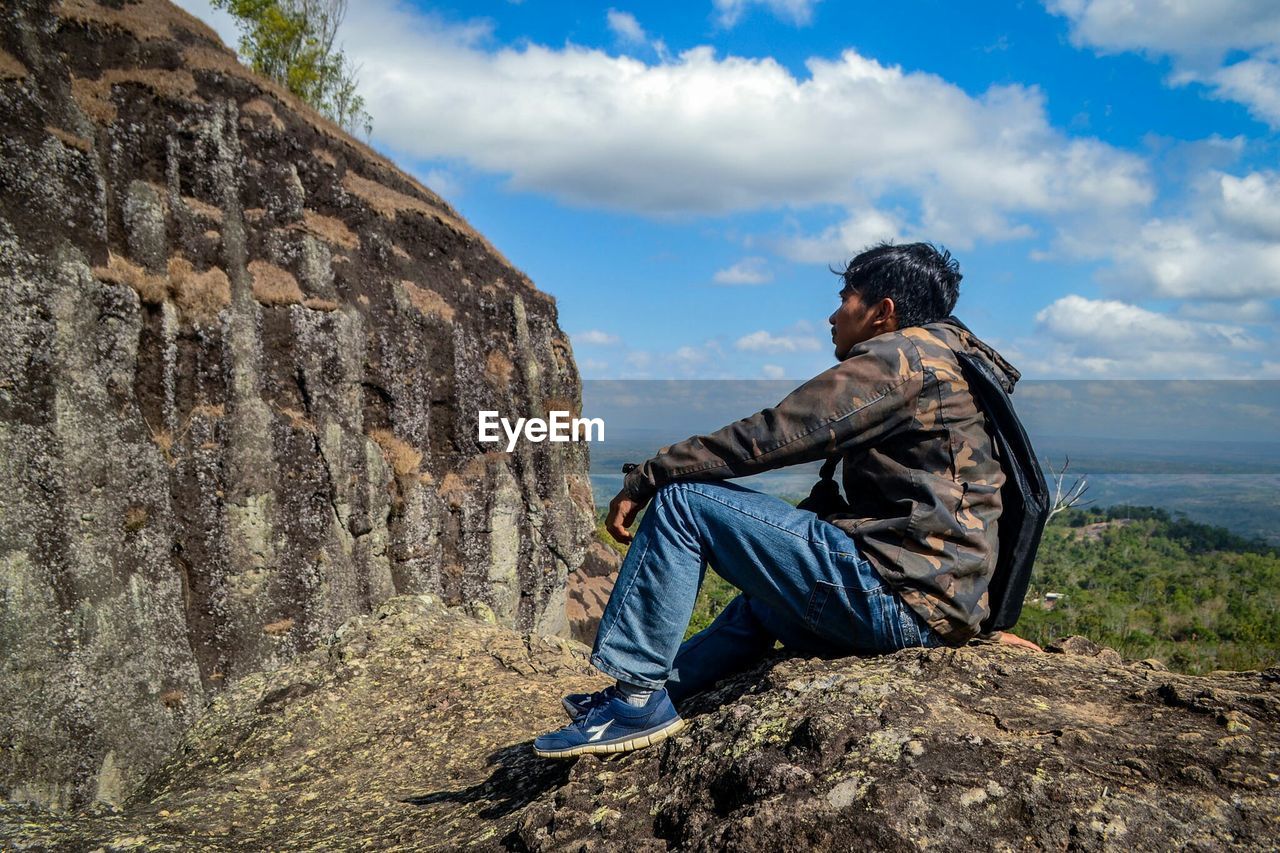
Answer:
0;0;593;806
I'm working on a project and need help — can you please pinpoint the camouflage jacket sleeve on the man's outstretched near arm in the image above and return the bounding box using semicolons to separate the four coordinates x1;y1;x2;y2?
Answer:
622;333;923;503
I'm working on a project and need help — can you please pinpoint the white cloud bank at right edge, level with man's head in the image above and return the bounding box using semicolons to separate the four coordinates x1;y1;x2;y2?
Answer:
1024;170;1280;378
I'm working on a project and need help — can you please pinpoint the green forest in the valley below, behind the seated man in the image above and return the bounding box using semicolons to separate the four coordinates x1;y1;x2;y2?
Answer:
599;506;1280;674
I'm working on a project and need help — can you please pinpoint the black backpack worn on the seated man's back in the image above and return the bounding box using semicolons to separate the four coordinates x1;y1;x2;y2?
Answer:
799;333;1051;634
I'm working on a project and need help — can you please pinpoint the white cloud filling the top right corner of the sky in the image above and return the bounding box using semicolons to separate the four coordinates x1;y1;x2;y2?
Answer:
1046;0;1280;127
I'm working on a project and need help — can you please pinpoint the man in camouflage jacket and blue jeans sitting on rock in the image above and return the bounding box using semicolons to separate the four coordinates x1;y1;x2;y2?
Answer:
534;243;1025;758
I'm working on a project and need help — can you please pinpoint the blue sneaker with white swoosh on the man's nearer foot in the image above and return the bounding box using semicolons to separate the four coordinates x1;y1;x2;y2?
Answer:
534;689;685;758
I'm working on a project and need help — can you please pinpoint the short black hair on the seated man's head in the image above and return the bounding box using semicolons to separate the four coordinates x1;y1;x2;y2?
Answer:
832;242;964;329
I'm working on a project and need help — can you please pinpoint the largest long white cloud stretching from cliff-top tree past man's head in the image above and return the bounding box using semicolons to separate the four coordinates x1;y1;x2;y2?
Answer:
282;0;1152;249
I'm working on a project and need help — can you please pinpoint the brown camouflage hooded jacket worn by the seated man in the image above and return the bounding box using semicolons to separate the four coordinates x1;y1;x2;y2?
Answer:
623;320;1019;644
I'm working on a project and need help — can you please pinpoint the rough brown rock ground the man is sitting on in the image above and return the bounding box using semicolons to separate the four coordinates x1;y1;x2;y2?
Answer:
0;597;1280;852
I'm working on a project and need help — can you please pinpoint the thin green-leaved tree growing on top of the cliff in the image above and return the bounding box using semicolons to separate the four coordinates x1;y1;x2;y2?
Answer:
212;0;372;136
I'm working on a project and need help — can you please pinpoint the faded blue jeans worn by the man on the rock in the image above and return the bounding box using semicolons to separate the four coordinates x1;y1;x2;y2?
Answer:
591;482;942;702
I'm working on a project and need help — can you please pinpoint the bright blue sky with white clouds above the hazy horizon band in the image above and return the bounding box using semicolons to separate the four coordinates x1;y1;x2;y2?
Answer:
180;0;1280;379
